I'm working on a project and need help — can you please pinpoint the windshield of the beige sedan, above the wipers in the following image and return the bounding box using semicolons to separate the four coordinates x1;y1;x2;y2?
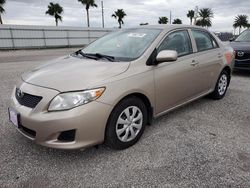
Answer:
82;28;161;61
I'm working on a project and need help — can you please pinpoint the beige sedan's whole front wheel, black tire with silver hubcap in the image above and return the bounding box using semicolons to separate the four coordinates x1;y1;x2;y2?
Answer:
105;97;148;150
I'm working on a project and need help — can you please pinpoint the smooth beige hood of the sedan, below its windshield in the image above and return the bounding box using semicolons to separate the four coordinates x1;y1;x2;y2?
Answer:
22;56;130;92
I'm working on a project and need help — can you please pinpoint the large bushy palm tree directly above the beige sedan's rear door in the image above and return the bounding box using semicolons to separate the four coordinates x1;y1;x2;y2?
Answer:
196;8;214;27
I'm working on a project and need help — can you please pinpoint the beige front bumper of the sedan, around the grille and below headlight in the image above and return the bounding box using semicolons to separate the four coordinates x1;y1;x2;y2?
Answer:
11;83;112;149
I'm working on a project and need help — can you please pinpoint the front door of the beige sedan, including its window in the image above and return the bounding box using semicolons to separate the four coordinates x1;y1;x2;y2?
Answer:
154;30;203;114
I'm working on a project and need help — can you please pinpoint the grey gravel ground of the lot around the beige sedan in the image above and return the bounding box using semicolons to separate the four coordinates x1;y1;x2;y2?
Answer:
0;49;250;188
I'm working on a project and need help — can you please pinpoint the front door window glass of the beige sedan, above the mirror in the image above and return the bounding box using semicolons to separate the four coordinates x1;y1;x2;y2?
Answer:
157;30;193;56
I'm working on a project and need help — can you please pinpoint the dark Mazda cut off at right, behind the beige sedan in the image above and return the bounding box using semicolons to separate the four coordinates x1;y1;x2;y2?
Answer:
231;29;250;70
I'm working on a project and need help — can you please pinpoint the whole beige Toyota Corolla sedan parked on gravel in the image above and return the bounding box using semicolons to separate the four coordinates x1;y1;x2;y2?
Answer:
9;25;234;149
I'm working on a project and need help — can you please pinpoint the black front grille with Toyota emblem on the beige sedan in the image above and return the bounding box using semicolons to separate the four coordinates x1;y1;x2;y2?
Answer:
15;89;42;108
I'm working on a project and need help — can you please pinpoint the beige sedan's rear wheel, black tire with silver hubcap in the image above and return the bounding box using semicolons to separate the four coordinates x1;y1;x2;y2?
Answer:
210;70;230;100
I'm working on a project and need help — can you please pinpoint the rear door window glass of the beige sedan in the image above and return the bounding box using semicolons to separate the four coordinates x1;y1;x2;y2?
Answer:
192;30;218;52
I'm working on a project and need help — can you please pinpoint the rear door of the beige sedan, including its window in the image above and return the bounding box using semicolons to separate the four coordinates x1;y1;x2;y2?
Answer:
191;29;223;93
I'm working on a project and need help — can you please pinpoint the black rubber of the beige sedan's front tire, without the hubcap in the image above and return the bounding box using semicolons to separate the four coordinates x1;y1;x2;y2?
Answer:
105;97;147;150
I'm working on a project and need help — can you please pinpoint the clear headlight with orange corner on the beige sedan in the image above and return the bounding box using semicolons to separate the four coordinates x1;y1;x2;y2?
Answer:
48;88;105;111
